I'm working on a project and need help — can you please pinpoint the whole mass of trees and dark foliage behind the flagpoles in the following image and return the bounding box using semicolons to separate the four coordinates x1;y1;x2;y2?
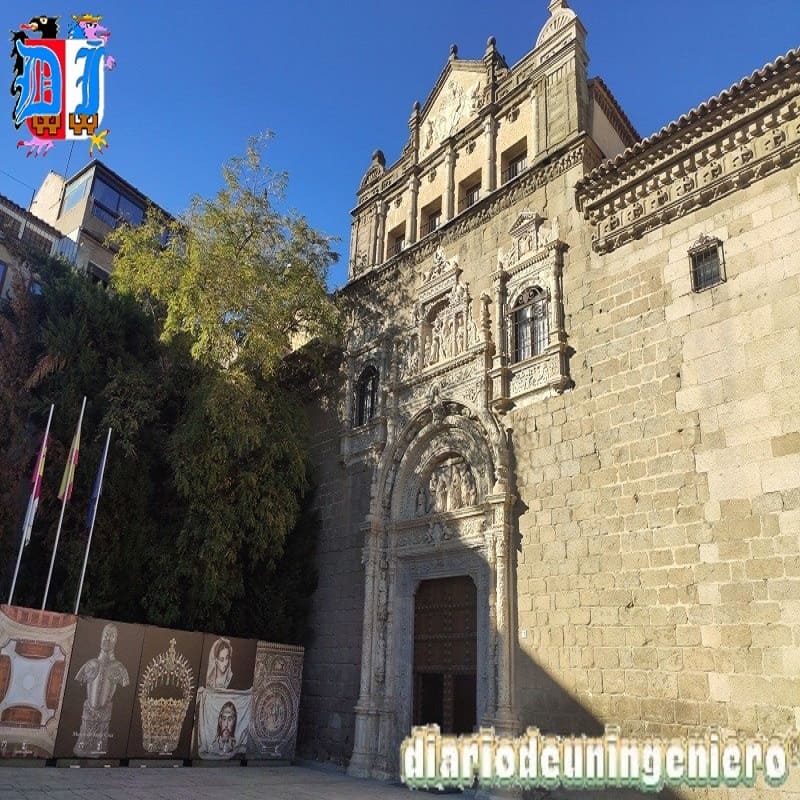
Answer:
0;140;337;641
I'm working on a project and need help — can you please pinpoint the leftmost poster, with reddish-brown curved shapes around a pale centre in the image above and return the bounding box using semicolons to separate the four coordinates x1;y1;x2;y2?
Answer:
0;605;76;758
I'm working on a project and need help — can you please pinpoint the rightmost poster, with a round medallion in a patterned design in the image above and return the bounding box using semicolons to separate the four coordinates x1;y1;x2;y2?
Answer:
248;642;304;761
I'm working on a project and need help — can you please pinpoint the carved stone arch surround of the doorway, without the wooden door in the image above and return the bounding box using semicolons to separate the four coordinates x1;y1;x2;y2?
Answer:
348;393;518;779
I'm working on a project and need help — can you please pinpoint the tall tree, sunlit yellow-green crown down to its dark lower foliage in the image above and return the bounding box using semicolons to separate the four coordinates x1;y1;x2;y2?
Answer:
104;137;338;630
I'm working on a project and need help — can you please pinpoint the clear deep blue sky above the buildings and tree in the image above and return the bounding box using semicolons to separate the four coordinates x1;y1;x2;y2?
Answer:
0;0;800;286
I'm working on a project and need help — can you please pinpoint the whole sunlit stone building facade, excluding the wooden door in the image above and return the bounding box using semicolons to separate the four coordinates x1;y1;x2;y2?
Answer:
299;0;800;797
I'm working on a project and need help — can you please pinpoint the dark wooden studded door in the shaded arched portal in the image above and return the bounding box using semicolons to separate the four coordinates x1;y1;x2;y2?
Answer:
414;576;478;734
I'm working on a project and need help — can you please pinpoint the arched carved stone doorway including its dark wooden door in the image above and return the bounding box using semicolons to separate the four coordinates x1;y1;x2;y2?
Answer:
348;398;518;778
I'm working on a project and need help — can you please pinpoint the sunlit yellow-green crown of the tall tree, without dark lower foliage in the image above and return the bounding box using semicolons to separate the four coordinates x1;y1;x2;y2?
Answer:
111;136;337;377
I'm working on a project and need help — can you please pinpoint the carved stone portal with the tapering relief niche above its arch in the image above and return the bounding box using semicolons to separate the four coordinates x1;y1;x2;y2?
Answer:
349;244;519;779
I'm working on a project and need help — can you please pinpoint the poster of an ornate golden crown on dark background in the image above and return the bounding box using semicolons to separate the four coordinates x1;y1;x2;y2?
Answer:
128;625;203;759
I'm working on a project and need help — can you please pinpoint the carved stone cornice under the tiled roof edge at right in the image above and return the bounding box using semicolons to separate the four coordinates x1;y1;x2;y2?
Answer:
576;50;800;253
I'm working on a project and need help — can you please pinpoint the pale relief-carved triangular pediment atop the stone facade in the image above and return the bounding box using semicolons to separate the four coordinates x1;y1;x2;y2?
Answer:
419;58;487;156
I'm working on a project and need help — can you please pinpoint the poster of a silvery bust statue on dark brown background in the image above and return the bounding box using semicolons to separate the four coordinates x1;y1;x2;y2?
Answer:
55;617;144;759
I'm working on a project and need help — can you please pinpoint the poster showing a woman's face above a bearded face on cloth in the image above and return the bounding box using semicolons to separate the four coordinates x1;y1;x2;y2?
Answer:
192;633;257;761
